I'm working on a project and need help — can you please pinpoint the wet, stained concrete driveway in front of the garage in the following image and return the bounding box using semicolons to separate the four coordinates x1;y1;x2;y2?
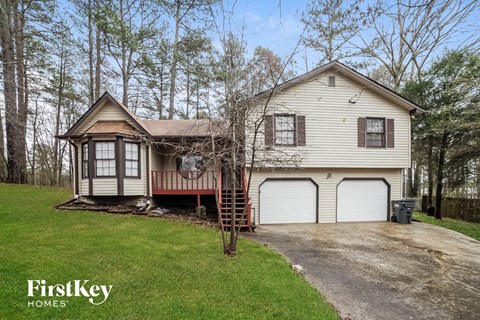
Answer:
248;222;480;319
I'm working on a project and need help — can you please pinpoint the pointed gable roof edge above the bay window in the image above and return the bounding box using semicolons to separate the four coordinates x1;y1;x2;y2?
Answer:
62;92;149;137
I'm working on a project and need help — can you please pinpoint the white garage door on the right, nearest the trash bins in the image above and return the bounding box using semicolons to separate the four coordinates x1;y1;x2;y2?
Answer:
337;180;388;222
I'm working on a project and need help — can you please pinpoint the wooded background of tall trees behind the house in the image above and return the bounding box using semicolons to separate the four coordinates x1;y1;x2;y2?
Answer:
0;0;480;217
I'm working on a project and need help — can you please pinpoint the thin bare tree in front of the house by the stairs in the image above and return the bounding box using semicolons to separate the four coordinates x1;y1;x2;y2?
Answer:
206;3;305;256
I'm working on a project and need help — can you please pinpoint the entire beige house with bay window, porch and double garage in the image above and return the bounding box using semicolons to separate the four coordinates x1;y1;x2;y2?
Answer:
58;61;423;227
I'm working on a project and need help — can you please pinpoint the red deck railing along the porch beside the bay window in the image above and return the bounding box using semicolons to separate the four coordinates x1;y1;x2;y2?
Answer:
152;171;216;194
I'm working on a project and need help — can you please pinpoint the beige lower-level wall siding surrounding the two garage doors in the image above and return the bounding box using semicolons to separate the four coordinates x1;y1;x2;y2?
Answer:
249;168;401;224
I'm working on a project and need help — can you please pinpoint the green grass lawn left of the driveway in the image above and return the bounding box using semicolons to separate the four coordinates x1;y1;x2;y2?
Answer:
0;184;338;319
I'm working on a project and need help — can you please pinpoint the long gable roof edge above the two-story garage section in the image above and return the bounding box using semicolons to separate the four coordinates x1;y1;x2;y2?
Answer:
253;60;425;114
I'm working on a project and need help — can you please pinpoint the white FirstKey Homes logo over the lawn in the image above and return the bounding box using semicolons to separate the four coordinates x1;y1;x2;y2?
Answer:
27;280;113;308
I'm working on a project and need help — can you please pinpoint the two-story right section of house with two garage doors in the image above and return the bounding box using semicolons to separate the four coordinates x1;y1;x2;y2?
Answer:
247;61;423;224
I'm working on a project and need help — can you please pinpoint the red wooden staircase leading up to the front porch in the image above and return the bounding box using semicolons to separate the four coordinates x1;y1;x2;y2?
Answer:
217;169;253;231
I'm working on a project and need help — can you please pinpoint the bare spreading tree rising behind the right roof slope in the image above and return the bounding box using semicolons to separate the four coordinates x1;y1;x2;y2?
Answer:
350;0;480;91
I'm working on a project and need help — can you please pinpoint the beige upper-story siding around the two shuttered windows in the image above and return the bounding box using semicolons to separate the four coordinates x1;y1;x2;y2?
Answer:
247;72;410;168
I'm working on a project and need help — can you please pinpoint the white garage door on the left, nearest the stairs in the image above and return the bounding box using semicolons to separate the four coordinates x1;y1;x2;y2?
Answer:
260;180;317;224
